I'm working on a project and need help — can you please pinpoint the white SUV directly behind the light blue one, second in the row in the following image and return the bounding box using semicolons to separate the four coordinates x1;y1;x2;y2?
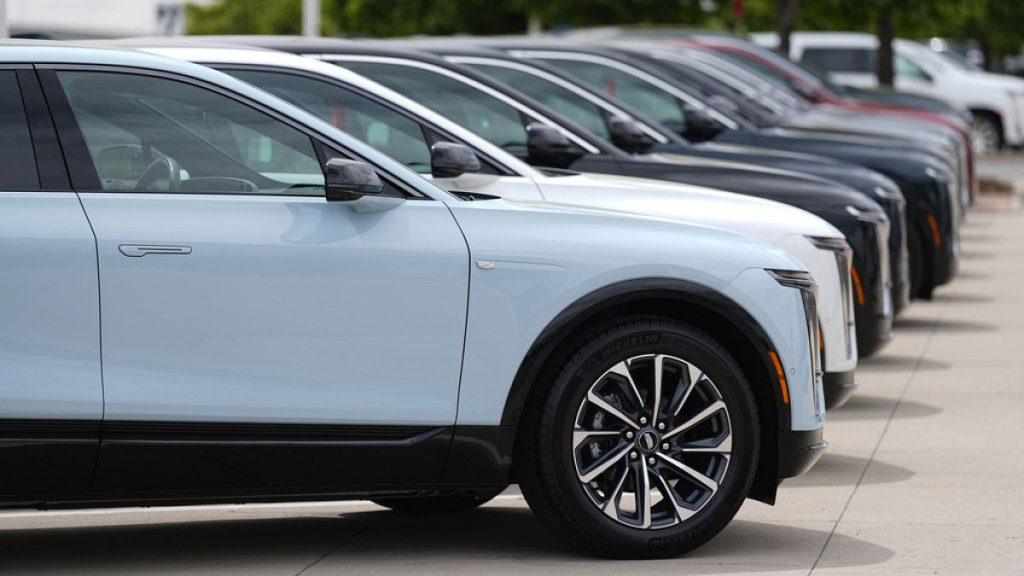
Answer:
131;41;857;408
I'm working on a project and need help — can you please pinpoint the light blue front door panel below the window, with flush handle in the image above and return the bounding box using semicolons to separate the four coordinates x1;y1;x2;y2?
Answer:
81;193;469;424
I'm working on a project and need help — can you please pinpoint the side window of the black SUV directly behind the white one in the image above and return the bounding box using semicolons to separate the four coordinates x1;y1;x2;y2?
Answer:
344;61;526;155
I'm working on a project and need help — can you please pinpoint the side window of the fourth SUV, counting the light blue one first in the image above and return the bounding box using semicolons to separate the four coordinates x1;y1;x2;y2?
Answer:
469;64;611;140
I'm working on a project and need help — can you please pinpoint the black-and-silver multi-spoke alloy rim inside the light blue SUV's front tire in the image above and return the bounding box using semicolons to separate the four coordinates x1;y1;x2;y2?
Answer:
571;354;732;530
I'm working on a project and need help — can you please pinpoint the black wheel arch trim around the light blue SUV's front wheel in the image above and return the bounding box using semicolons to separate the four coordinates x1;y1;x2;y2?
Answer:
501;278;792;503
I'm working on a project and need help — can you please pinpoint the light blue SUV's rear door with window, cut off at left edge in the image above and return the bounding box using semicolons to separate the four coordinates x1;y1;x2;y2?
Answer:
0;66;103;487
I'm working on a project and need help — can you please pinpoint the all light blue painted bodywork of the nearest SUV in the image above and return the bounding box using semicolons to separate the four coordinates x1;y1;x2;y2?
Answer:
0;44;820;438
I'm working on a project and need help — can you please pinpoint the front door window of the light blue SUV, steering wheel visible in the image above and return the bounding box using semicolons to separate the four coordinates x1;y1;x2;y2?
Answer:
57;72;324;196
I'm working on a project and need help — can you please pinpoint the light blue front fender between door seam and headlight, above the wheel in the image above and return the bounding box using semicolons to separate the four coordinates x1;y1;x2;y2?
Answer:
453;201;807;425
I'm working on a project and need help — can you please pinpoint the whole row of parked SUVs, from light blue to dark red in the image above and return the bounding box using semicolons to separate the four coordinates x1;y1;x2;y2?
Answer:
0;34;975;558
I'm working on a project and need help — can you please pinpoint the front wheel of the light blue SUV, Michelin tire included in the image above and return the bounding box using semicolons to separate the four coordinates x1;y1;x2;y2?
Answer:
514;317;760;559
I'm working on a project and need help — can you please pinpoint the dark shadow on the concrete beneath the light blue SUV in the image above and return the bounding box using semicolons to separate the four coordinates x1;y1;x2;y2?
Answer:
0;500;893;576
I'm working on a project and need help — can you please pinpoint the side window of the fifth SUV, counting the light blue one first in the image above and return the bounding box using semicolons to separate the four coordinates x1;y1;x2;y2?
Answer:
545;58;686;132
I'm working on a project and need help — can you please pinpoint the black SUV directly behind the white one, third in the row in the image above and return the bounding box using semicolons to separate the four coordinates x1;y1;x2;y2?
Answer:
218;37;893;356
